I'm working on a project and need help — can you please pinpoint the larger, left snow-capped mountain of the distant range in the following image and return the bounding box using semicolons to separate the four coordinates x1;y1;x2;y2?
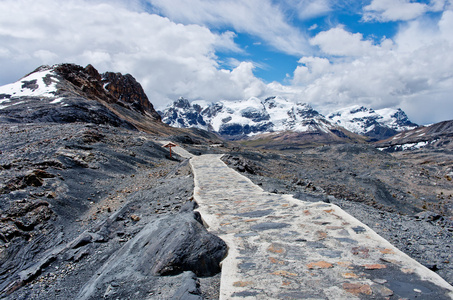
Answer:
161;97;360;139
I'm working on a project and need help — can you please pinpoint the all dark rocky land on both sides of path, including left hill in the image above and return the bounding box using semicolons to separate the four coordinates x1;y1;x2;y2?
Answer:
0;64;453;299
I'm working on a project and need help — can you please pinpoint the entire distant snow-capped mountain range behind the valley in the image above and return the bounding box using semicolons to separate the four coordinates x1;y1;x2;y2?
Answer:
160;96;418;141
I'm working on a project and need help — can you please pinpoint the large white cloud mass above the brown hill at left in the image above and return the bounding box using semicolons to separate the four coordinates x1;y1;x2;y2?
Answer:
0;0;263;106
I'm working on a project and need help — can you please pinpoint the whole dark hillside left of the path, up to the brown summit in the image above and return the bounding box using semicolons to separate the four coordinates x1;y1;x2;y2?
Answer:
0;64;226;299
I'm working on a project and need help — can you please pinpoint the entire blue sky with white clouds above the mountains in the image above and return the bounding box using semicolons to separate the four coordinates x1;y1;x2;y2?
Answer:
0;0;453;124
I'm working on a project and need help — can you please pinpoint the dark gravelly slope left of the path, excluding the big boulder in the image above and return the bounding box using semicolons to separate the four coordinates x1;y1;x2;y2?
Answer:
0;123;220;299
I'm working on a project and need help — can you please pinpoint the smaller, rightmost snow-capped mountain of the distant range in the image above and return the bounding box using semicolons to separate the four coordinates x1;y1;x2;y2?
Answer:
327;105;418;140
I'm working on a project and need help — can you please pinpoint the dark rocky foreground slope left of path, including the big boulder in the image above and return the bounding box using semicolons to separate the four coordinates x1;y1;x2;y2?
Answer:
0;120;231;299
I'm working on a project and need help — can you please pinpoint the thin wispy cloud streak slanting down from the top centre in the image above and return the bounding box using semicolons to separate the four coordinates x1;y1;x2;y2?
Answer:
147;0;310;55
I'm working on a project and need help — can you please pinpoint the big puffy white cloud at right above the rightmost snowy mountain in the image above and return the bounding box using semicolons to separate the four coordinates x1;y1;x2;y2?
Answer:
286;7;453;124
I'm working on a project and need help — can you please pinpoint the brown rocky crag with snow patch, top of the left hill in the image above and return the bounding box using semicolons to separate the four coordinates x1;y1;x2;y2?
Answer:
0;64;160;120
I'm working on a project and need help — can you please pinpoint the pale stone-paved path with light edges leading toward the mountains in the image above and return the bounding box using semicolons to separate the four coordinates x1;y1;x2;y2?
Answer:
190;155;453;299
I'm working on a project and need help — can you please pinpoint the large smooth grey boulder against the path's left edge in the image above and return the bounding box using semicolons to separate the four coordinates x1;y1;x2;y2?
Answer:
78;202;227;299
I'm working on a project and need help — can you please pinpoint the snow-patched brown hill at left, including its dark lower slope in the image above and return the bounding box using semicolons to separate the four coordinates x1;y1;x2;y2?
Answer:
0;64;160;127
